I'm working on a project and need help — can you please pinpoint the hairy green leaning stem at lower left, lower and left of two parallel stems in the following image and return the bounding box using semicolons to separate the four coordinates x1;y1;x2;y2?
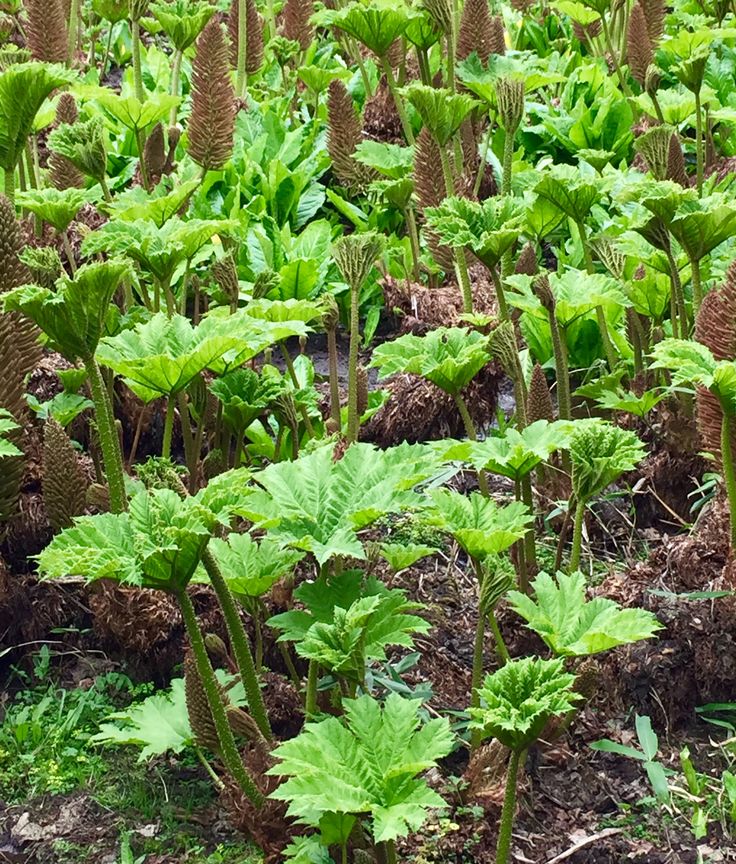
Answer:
176;591;265;807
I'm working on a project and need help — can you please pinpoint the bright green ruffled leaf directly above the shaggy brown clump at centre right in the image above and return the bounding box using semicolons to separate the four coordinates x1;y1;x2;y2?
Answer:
370;327;490;395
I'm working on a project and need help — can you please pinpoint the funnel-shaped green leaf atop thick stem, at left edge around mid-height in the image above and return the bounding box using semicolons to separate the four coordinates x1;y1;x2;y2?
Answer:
5;259;130;362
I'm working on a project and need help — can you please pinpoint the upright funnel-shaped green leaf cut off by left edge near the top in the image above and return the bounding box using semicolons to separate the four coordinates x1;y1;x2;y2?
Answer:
0;63;77;171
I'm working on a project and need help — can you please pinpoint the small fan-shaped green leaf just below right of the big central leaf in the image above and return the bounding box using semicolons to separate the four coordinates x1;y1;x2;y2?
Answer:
429;489;532;561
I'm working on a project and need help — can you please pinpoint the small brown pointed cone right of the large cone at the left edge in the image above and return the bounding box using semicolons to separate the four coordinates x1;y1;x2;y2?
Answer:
41;419;87;531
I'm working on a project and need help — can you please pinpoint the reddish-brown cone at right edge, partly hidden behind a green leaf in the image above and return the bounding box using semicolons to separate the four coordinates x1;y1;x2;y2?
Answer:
695;262;736;460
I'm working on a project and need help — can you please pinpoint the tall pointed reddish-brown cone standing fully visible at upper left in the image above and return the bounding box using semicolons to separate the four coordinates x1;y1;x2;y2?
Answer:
188;18;235;171
